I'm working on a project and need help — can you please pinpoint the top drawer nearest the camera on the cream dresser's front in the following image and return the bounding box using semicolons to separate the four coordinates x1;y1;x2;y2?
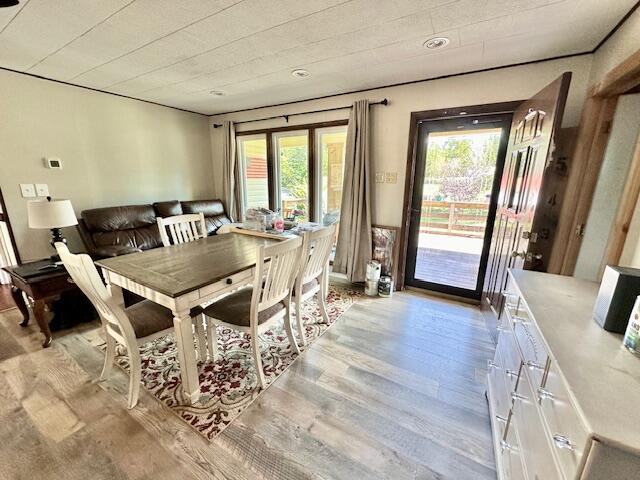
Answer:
536;365;588;478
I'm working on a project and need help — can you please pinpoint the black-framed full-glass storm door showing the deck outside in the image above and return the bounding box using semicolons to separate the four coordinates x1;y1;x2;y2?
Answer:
405;114;511;300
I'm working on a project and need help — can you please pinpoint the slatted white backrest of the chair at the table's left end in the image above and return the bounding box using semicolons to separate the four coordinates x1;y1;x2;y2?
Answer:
55;242;136;349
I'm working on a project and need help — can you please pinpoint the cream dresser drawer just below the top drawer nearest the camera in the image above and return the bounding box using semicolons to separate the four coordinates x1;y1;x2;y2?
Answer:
512;371;562;480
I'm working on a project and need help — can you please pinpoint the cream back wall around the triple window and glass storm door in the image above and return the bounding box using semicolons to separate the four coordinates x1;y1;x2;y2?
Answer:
211;55;592;226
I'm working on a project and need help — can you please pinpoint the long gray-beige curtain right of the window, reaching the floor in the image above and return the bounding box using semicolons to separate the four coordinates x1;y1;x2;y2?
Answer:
333;100;372;282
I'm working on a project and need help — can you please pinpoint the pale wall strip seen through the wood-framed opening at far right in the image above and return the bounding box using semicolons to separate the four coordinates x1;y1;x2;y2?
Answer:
574;94;640;281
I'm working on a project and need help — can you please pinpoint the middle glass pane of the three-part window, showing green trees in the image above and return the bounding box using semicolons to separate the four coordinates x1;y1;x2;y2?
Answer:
273;130;311;222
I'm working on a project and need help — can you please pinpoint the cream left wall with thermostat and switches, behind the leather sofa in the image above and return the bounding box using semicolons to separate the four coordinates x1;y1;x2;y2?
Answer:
0;71;214;260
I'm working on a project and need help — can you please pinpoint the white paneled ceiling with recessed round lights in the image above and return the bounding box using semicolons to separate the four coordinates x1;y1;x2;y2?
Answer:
0;0;636;114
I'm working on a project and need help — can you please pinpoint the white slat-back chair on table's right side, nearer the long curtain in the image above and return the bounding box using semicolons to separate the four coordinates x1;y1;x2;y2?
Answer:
292;225;336;345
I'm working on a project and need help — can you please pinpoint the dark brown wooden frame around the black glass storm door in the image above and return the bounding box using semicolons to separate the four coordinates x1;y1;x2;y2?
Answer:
396;100;522;290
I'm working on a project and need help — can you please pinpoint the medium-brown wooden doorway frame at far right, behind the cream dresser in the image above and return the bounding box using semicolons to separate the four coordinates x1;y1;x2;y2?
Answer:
548;50;640;277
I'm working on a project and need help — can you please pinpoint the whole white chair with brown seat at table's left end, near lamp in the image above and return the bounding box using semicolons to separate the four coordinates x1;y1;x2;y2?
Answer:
55;242;205;408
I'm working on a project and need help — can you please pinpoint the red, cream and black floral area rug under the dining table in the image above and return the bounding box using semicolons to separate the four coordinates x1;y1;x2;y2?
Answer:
97;285;362;440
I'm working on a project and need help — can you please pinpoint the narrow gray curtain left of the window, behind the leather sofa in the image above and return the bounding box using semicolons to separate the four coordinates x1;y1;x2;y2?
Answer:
222;120;244;222
